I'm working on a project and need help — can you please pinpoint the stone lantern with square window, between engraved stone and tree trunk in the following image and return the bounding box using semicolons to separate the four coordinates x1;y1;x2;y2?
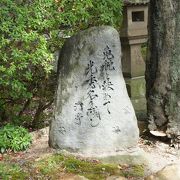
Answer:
120;0;149;119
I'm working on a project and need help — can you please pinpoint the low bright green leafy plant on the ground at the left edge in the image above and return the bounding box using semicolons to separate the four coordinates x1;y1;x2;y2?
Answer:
0;124;32;153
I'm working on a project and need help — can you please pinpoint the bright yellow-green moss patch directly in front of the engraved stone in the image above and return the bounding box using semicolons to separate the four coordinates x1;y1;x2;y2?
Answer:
35;154;144;180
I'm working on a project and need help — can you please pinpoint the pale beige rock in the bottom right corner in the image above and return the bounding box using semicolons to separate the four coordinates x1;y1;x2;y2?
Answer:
145;164;180;180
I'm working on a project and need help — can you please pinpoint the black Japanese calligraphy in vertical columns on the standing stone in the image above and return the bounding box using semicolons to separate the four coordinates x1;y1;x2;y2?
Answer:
74;45;115;127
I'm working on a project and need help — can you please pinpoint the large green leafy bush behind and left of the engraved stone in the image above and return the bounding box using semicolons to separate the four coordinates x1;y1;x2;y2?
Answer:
0;0;122;127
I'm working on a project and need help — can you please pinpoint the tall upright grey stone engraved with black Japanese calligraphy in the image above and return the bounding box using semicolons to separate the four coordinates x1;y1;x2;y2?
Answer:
49;26;139;157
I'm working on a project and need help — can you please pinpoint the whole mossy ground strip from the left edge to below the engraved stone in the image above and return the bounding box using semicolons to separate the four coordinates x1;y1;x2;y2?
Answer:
0;154;144;180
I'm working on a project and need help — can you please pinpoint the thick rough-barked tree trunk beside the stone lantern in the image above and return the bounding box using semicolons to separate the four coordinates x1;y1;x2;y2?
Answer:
146;0;180;136
